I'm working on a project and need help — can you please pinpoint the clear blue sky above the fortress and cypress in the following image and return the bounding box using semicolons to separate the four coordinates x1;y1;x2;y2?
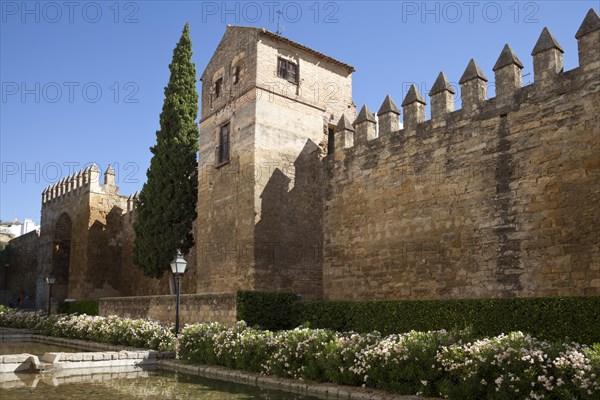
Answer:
0;0;599;222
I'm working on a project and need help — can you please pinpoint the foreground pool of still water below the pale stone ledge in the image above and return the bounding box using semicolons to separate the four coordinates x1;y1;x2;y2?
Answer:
0;370;326;400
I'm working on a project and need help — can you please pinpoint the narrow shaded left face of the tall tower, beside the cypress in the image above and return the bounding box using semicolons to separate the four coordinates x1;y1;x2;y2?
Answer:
195;27;258;293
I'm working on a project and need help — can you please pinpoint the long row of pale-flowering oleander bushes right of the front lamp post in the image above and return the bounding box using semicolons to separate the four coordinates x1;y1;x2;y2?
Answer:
179;321;600;400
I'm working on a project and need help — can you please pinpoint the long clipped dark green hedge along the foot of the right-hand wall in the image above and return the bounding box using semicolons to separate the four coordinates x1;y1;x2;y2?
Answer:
238;292;600;344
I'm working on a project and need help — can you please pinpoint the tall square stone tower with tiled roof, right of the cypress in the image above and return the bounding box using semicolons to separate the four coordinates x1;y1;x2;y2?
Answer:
196;26;356;298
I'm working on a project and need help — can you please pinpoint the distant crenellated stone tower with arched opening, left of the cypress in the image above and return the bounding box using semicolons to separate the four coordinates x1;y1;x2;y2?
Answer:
36;164;127;301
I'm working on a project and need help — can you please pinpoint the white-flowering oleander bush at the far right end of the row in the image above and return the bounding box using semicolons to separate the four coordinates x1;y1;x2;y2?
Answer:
436;332;600;399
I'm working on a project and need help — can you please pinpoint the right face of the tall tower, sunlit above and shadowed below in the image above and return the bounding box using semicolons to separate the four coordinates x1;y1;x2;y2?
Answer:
254;36;356;298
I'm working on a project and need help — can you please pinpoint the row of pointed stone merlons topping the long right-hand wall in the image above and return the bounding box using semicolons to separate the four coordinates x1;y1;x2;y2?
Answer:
334;9;600;153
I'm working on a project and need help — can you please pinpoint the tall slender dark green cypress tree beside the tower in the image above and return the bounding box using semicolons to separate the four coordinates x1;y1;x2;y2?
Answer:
133;24;199;278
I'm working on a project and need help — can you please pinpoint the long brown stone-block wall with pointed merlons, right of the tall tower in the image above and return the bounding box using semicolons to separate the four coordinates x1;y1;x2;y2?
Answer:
323;10;600;300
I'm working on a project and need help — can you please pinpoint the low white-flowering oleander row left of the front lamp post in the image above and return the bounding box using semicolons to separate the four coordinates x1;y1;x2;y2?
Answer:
0;311;175;351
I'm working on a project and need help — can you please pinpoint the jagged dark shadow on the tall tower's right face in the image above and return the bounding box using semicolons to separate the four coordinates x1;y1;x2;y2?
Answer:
254;140;323;299
